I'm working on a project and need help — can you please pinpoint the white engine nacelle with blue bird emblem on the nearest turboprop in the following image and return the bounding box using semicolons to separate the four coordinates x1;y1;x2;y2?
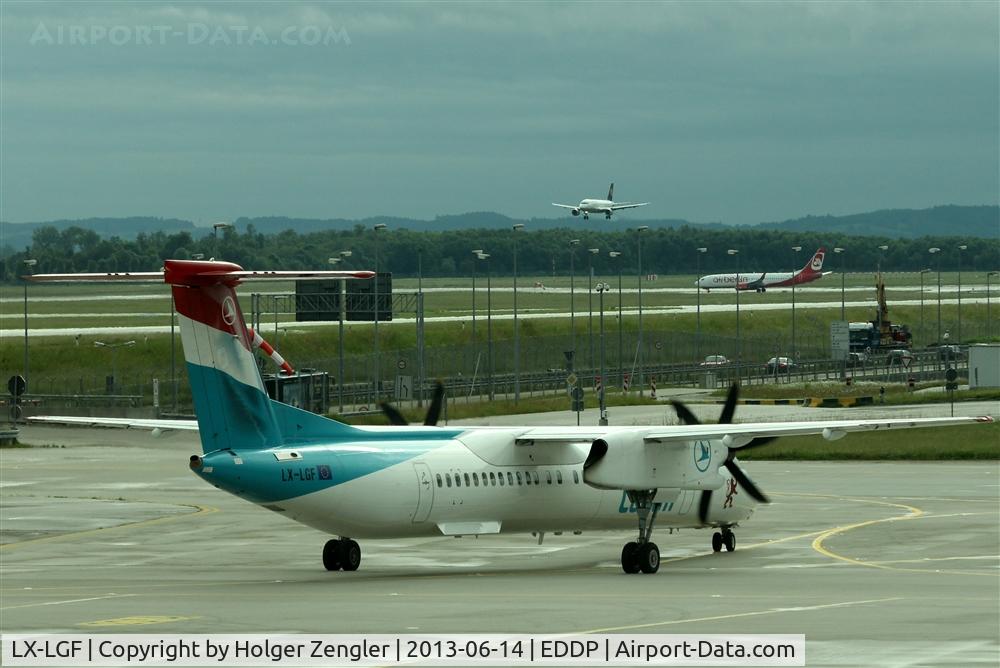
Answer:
583;432;728;490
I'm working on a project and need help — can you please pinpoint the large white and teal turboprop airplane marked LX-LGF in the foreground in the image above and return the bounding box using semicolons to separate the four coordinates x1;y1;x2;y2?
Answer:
25;260;992;573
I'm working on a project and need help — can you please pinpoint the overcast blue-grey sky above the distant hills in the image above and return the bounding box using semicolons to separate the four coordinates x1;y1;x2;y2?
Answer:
0;0;1000;224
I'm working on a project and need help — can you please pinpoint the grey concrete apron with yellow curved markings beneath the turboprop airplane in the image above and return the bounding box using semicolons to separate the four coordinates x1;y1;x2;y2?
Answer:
0;422;1000;666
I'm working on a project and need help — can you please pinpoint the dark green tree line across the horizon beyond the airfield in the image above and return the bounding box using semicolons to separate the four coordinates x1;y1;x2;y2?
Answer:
0;222;1000;282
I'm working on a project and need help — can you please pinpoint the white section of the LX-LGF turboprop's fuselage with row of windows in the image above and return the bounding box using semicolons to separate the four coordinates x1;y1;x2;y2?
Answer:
242;440;755;538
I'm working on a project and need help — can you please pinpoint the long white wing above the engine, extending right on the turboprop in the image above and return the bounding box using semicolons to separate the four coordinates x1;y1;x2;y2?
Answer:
516;416;993;449
